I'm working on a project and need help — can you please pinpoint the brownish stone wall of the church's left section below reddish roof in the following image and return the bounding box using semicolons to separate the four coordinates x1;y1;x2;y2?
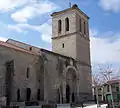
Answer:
0;46;39;101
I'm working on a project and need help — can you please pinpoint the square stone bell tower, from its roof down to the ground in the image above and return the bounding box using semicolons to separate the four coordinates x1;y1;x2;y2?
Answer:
51;4;92;100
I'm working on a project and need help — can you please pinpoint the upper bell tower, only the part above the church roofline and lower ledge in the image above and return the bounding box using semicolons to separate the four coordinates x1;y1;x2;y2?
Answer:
51;4;90;64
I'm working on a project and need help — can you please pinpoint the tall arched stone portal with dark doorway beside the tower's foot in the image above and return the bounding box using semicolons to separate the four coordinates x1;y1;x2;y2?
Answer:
65;66;78;103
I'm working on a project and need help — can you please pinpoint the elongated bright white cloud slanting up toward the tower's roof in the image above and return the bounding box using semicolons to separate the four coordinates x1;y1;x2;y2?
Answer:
11;1;57;23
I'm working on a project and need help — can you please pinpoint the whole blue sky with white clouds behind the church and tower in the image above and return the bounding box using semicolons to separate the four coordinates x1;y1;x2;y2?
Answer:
0;0;120;74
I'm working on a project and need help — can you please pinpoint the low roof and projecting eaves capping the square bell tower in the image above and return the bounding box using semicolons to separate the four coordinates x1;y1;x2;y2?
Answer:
51;4;89;19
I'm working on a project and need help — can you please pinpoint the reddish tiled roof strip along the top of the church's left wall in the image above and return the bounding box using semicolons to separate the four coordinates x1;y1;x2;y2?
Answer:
0;41;38;55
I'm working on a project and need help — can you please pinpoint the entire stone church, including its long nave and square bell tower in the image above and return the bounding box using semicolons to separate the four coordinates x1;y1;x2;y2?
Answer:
0;5;92;103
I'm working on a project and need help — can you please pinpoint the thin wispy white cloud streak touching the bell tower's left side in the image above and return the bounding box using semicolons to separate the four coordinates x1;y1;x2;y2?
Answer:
8;21;52;43
